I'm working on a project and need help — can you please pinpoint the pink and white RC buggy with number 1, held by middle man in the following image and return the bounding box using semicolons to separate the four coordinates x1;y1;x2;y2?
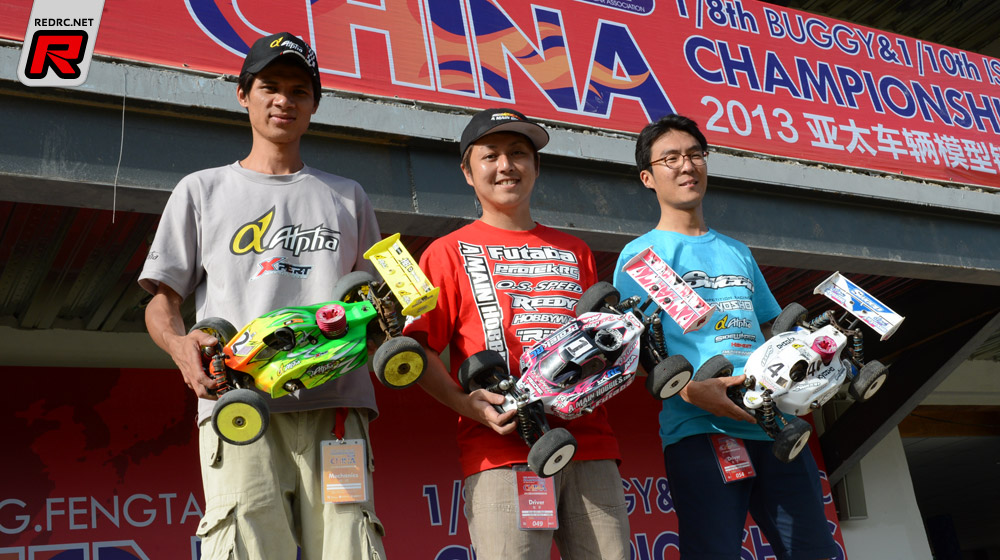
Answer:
458;250;715;477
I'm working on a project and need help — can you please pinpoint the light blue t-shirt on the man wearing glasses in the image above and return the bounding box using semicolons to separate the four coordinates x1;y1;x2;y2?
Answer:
614;230;781;447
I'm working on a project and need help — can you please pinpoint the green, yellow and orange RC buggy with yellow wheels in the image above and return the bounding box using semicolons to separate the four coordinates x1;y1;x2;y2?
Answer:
191;234;438;445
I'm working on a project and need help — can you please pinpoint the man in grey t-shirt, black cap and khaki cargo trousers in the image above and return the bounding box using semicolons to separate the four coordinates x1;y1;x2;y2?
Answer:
139;33;385;560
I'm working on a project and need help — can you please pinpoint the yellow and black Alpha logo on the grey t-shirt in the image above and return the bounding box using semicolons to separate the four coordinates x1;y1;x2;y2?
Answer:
229;206;340;257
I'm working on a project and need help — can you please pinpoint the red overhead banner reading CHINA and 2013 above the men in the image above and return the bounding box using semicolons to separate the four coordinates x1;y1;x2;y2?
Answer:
0;0;1000;188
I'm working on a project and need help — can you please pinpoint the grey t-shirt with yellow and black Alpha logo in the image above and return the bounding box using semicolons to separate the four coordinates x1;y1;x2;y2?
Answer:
139;162;381;422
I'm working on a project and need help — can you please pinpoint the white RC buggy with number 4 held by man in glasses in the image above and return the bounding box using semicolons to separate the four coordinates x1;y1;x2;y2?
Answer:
695;273;903;462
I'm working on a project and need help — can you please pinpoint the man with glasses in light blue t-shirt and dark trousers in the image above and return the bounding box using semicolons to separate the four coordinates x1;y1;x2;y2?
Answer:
614;115;839;560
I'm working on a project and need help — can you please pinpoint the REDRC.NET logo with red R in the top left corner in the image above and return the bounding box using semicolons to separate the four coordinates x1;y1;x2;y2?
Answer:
17;0;104;87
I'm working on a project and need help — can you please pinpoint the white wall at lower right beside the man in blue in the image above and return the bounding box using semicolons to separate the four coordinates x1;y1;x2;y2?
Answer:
840;429;931;560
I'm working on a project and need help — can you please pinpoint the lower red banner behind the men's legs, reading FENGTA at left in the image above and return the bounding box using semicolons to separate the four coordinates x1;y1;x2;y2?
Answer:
0;367;847;560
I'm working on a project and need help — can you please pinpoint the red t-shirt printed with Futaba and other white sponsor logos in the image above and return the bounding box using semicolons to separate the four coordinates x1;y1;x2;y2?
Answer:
403;221;621;477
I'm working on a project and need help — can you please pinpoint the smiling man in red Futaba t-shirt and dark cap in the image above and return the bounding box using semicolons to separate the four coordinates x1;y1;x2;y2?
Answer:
404;109;629;560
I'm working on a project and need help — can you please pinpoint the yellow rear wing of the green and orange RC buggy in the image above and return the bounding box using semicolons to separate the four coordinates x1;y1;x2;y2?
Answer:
365;233;440;317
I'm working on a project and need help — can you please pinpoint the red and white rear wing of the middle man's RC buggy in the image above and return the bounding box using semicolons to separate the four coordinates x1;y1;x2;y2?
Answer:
622;247;715;334
